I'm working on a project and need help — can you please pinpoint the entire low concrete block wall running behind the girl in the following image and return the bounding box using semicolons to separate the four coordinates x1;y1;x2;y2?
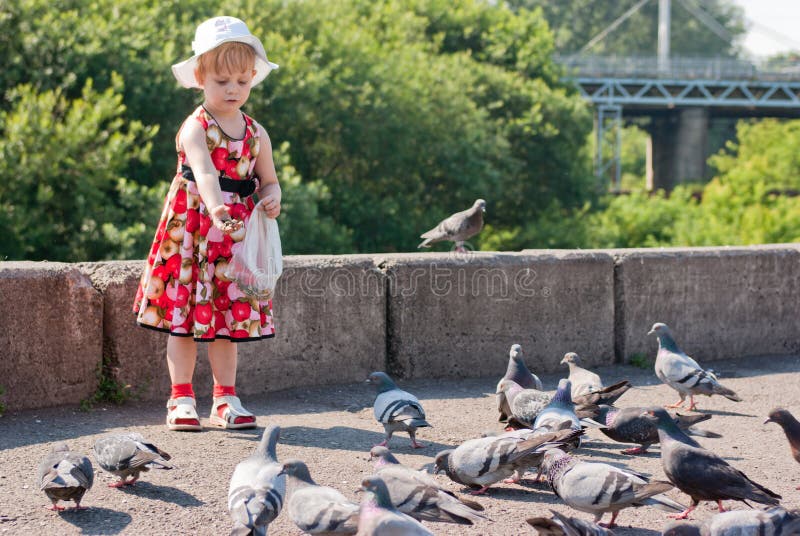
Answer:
0;245;800;410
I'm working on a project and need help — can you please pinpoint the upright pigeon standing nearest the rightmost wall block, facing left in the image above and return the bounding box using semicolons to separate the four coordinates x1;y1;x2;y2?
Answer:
648;322;742;411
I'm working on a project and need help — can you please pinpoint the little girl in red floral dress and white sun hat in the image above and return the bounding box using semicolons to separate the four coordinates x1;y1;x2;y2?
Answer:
133;17;281;430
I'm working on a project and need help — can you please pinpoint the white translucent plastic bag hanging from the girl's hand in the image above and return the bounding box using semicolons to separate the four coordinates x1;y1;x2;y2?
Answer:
225;208;283;300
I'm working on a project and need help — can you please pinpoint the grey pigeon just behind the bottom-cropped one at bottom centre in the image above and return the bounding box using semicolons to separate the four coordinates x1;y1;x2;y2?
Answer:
369;447;488;525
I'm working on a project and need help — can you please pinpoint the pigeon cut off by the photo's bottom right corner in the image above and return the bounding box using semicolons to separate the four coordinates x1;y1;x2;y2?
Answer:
661;506;800;536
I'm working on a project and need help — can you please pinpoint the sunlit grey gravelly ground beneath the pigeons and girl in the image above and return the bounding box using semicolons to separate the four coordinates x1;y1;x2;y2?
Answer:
0;357;800;535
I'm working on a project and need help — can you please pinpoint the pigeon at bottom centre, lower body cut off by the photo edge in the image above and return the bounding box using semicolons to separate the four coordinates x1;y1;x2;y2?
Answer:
357;476;433;536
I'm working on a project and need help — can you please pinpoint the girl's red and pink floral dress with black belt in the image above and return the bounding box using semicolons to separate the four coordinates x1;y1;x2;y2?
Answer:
133;106;275;342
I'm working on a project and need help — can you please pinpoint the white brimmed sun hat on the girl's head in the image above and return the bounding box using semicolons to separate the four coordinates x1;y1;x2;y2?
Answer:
172;17;278;88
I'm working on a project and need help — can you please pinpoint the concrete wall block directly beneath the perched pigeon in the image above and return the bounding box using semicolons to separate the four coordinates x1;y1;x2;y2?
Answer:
383;251;614;378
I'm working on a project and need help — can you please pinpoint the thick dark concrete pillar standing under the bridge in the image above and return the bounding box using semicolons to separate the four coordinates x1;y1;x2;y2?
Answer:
647;108;708;191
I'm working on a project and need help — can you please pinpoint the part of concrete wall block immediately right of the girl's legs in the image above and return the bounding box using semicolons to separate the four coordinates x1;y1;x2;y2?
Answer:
237;255;386;393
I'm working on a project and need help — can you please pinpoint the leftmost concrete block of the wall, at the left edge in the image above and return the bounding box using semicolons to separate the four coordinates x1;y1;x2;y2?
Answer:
0;262;103;410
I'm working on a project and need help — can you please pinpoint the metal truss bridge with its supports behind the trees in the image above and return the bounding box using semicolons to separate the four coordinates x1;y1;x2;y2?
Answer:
555;0;800;190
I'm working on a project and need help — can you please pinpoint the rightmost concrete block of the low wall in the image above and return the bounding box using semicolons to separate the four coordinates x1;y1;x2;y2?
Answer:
613;245;800;364
